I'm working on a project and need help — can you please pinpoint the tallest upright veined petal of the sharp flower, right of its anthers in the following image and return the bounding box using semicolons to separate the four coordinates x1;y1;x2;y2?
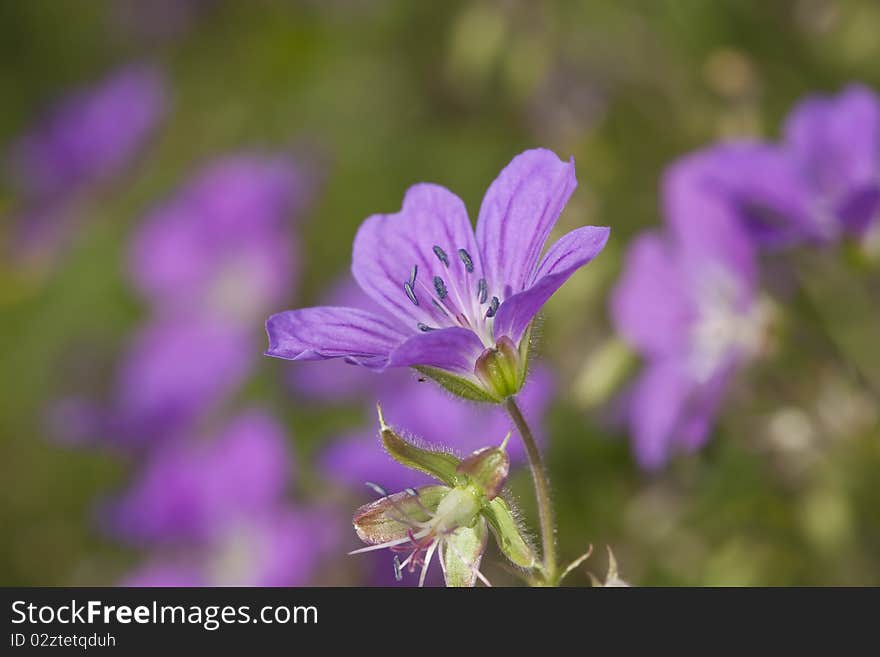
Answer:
477;148;577;300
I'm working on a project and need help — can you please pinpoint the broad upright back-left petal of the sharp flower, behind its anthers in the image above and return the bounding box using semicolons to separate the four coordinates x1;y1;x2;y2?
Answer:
351;183;483;331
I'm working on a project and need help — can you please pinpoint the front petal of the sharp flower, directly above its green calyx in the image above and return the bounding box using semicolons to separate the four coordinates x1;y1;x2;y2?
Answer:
388;327;485;378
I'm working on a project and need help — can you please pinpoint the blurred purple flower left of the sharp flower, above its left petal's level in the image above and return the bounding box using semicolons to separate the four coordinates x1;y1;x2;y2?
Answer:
129;155;306;324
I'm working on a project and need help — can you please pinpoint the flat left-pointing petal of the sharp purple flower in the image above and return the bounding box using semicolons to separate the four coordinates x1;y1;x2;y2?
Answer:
266;306;405;370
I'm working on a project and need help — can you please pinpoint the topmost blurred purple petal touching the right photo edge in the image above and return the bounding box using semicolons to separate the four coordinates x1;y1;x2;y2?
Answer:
785;85;880;201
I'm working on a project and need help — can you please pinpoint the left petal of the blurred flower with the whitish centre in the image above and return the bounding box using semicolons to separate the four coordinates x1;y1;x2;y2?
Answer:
611;233;696;355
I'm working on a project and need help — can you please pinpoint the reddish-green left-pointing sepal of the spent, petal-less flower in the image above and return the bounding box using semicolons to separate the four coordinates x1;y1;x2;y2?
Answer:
353;486;449;545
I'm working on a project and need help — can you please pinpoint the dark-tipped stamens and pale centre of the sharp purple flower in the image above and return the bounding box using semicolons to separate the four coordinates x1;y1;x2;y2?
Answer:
403;244;501;347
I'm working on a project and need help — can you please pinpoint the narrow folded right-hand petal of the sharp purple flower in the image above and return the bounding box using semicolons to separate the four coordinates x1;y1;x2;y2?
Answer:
494;226;611;342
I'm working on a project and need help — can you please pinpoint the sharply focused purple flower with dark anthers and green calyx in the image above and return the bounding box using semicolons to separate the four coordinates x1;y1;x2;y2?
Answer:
266;149;609;401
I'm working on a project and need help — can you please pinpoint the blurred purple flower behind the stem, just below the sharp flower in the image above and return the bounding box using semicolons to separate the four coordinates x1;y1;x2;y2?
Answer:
321;367;553;490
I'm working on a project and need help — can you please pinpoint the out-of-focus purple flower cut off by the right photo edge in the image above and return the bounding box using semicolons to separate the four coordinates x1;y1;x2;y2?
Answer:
684;85;880;249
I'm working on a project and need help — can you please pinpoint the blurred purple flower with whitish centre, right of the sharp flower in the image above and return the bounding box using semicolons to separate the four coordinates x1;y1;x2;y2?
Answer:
611;159;763;468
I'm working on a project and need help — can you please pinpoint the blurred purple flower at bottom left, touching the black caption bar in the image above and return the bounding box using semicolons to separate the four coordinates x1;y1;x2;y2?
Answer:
109;410;338;586
